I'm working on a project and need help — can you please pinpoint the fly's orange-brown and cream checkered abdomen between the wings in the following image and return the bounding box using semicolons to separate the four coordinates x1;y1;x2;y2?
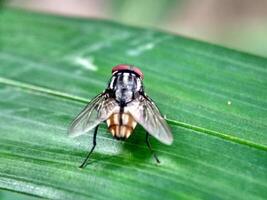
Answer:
107;113;137;139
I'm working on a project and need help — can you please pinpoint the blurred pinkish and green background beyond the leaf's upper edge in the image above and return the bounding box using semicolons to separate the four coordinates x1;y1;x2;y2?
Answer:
3;0;267;57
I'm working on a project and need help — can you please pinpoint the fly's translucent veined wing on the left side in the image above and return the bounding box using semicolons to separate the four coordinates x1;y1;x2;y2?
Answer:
69;93;118;137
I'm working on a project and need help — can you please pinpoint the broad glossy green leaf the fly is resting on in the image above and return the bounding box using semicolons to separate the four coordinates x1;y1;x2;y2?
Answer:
0;10;267;199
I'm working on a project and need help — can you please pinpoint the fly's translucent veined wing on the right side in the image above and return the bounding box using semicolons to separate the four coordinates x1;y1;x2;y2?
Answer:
127;95;173;145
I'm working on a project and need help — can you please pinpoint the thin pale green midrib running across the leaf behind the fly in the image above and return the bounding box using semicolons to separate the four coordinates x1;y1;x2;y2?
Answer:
0;77;267;151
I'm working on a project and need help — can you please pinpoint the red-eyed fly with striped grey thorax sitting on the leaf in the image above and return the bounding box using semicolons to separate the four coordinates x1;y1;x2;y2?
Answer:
69;64;173;168
